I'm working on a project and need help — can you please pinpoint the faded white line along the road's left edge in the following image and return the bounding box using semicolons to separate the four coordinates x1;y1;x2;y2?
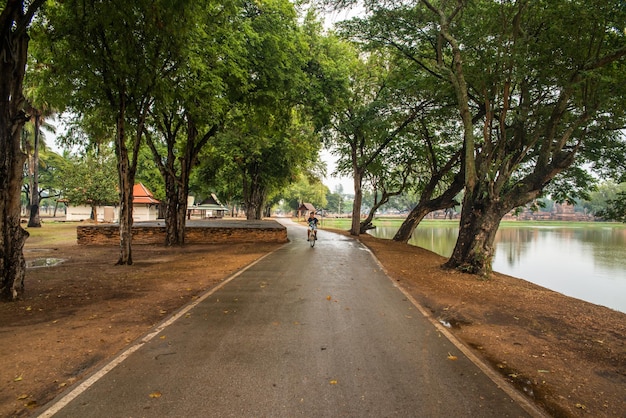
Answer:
38;246;282;418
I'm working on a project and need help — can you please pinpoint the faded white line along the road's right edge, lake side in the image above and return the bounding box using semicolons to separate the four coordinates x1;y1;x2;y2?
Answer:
359;241;548;418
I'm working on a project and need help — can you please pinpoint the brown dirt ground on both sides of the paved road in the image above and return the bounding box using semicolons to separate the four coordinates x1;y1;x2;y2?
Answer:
0;220;626;417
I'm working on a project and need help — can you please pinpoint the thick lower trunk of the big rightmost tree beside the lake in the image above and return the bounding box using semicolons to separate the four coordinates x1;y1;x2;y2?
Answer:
445;187;508;276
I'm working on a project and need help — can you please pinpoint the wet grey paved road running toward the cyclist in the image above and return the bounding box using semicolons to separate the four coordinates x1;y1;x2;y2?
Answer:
36;220;533;417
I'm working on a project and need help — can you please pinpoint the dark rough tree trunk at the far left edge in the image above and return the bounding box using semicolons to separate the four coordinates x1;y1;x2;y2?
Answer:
0;0;44;300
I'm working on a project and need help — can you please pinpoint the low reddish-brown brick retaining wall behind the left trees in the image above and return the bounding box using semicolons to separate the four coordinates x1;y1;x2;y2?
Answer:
76;221;287;245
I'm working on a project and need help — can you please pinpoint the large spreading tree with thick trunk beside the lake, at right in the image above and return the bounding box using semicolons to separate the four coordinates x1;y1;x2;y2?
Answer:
334;0;626;274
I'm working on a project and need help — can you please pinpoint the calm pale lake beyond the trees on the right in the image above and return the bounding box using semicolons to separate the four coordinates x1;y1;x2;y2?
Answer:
370;222;626;312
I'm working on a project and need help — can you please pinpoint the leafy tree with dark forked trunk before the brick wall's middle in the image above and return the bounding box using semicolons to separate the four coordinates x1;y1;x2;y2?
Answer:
146;1;248;245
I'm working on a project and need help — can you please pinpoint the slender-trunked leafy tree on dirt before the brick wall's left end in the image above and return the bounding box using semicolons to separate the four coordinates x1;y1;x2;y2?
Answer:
41;0;188;265
